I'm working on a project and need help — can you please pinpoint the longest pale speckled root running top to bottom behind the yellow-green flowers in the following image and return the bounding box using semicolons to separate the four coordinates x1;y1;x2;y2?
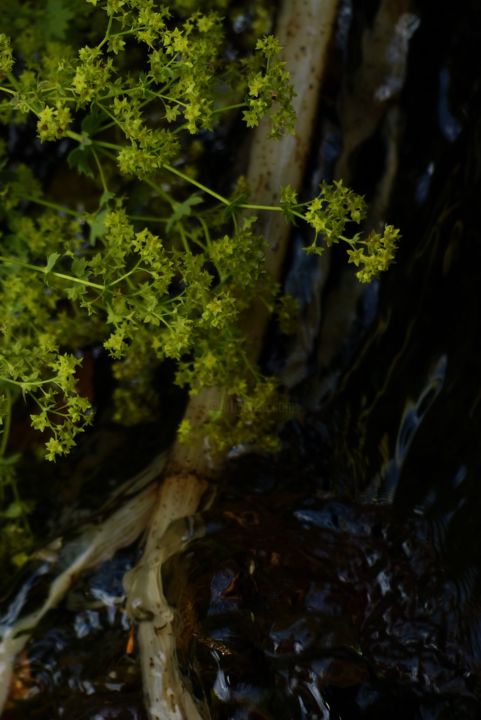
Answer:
131;0;337;720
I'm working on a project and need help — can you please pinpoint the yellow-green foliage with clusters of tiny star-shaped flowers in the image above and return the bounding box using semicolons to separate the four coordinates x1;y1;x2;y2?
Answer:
0;0;397;560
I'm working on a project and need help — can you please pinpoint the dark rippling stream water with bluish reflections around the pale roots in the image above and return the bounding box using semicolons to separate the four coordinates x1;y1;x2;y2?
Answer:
0;0;481;720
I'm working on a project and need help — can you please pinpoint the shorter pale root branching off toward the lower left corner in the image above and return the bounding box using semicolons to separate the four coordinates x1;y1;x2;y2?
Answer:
0;454;165;716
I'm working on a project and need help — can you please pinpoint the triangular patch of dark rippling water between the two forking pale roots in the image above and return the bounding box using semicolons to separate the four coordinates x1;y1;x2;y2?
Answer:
2;549;147;720
